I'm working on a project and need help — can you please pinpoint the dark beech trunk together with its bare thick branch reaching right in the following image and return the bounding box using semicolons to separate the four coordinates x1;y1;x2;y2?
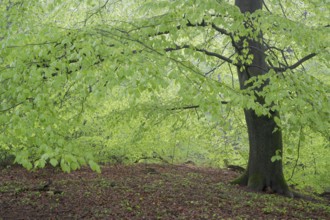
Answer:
233;0;328;196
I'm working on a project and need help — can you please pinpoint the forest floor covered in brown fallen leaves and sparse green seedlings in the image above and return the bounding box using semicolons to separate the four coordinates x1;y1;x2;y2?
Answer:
0;164;330;219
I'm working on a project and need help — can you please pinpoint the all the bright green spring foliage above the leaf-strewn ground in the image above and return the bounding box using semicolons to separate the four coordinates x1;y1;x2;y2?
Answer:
0;0;330;191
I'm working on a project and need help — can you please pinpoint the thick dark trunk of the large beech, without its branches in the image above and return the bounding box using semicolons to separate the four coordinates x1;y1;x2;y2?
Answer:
233;0;292;196
